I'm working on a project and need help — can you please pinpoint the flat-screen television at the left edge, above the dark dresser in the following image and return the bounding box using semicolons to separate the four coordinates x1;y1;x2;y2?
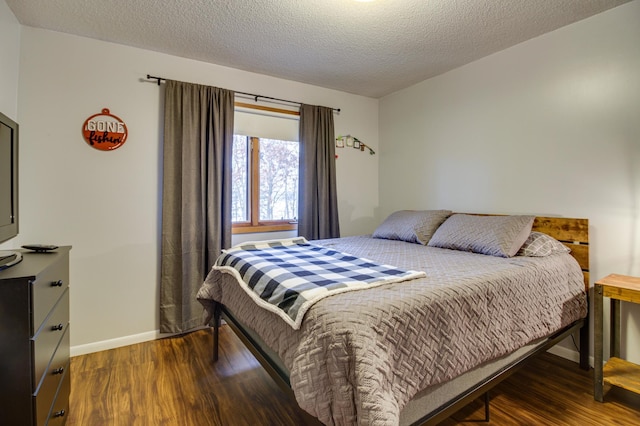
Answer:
0;113;18;243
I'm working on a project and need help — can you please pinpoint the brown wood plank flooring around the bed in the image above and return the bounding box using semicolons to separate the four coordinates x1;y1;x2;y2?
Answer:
67;326;640;426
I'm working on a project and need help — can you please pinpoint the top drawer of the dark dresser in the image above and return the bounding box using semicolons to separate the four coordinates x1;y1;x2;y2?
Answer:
31;253;69;336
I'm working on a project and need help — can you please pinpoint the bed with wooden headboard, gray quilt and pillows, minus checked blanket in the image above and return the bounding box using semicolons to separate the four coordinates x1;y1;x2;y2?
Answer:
198;211;589;425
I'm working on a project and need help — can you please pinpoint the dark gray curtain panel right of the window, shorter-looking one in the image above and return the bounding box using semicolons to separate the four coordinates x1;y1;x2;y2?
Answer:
298;105;340;240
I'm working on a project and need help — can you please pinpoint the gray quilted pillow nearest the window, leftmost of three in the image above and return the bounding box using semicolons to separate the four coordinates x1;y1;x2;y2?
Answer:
373;210;451;244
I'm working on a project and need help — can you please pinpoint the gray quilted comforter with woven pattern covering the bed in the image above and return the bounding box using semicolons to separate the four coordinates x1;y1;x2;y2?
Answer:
197;236;587;425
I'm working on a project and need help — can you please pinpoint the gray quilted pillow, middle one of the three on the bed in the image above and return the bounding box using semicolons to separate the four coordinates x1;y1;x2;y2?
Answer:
429;214;535;257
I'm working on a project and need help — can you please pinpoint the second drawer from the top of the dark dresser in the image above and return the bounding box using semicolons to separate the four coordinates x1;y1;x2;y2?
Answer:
32;289;69;389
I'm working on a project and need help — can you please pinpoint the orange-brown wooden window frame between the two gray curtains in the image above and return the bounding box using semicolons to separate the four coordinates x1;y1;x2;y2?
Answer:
231;130;299;234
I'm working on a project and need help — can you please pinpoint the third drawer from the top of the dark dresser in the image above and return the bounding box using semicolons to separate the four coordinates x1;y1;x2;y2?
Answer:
35;330;69;425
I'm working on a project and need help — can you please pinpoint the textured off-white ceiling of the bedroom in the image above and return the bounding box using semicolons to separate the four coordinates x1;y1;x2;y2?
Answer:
6;0;629;98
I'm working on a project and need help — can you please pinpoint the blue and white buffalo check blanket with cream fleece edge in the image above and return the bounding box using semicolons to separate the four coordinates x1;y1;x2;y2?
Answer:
213;237;426;330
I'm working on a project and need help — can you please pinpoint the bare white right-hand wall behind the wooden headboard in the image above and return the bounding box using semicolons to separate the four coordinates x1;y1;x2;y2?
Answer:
380;0;640;362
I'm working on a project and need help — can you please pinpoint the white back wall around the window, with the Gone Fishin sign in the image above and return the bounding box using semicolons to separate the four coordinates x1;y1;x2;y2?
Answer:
13;27;378;354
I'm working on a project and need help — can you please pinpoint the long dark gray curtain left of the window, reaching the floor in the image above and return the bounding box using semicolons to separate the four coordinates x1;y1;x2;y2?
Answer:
160;80;234;333
